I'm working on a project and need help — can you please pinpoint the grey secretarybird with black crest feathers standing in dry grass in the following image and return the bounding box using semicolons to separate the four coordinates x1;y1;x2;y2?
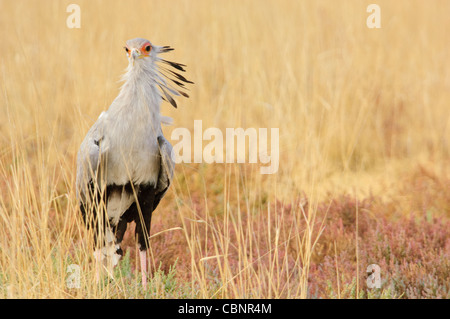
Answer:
76;38;193;288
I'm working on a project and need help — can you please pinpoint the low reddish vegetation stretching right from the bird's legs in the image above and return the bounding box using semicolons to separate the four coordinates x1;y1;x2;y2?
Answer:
119;168;450;298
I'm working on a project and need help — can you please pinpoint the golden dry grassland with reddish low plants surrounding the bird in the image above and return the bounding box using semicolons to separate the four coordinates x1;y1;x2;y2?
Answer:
0;0;450;298
